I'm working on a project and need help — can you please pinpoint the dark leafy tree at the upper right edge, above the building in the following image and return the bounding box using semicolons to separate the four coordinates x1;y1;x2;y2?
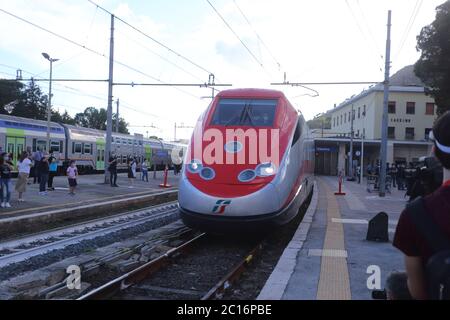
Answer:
414;0;450;115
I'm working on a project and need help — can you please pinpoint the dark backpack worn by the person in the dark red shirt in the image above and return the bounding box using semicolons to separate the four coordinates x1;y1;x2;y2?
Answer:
407;197;450;300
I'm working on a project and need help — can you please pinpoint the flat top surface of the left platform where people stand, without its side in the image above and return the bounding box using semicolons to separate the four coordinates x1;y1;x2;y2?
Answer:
0;171;181;221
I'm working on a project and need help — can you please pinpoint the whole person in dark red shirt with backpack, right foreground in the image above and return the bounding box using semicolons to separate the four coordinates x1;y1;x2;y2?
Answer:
393;112;450;300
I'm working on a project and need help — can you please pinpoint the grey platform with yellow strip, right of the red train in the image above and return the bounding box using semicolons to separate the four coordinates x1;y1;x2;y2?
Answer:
258;177;407;300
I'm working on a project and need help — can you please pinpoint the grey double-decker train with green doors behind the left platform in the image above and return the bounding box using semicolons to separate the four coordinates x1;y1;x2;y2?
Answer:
0;115;183;173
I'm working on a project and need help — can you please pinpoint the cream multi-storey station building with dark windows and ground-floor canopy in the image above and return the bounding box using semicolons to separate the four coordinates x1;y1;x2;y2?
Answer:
313;66;437;175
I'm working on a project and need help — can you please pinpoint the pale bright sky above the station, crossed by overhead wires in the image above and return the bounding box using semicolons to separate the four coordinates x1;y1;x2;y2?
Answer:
0;0;444;140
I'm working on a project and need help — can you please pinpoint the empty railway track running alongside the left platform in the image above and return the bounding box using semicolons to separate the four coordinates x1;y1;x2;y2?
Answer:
0;202;178;268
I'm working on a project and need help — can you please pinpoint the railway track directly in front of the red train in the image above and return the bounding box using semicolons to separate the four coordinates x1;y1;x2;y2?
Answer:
78;233;262;300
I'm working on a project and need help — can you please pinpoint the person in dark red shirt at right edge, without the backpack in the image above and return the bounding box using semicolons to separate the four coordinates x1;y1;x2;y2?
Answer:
393;111;450;300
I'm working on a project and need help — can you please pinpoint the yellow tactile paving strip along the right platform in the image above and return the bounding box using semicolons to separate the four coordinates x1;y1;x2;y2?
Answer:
316;180;351;300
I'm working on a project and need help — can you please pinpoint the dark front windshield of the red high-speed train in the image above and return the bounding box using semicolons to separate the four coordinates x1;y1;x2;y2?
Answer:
211;99;278;127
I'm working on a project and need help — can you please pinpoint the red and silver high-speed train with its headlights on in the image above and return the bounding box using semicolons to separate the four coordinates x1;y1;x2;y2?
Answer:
178;89;315;233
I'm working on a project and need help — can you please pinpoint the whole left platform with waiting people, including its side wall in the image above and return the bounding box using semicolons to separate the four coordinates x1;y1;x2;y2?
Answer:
0;171;181;239
